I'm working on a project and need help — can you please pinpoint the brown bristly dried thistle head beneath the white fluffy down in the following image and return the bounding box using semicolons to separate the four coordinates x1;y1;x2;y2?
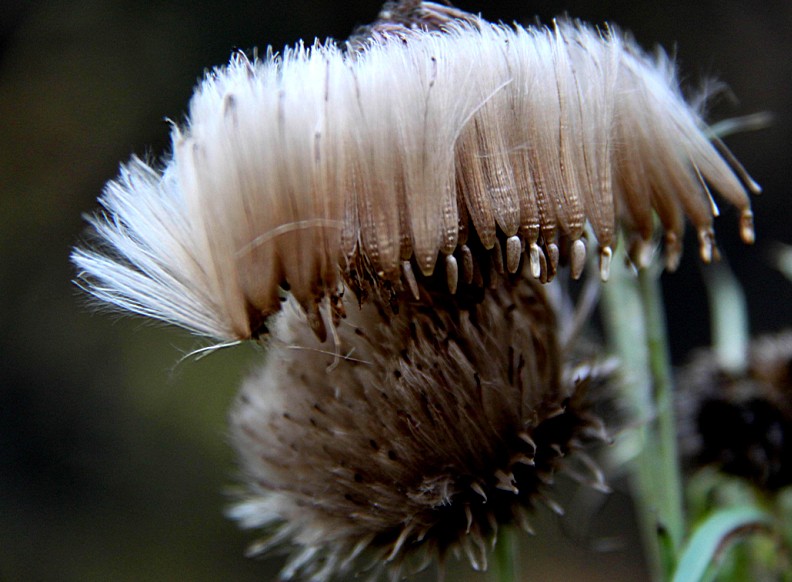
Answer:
226;279;605;580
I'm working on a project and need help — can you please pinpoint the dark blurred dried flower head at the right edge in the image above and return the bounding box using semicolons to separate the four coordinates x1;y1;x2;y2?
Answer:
679;331;792;491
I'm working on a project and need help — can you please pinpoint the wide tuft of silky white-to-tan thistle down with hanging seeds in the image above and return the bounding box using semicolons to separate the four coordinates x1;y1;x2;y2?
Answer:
73;11;758;340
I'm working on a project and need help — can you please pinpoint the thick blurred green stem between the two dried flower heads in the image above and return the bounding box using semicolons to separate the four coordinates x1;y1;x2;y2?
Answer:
602;261;685;581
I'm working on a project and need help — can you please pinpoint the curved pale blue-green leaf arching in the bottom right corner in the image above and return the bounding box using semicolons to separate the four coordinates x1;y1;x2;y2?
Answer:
673;505;772;582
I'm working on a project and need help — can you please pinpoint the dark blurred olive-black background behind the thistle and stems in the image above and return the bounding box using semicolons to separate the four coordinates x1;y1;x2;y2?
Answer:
0;0;792;581
